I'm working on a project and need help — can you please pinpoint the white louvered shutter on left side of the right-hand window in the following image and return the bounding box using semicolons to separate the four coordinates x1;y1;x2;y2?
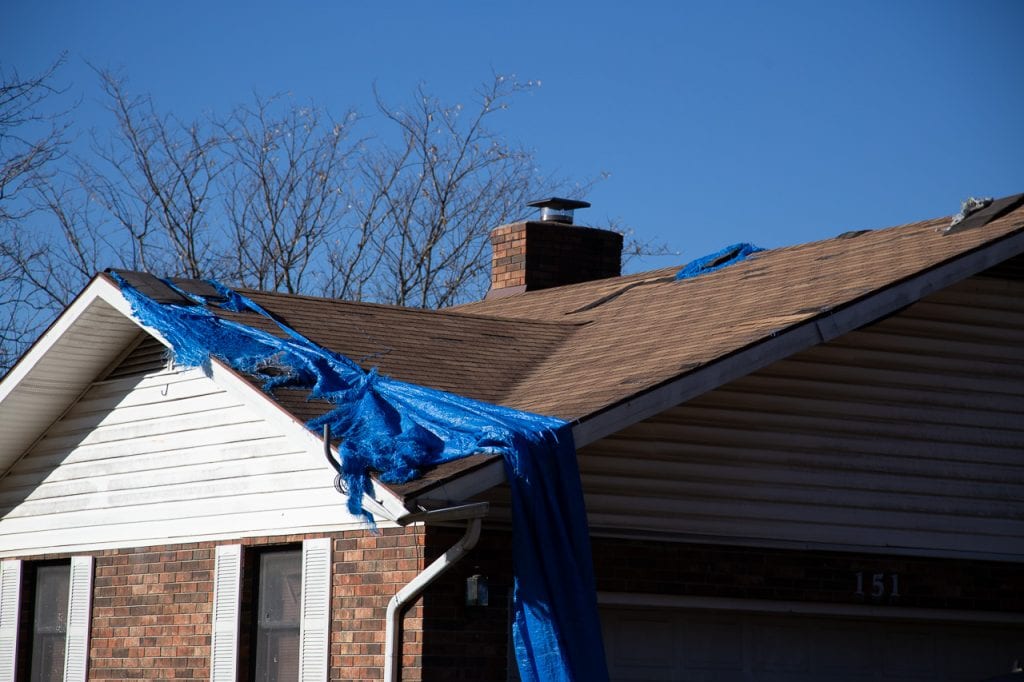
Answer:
210;545;242;682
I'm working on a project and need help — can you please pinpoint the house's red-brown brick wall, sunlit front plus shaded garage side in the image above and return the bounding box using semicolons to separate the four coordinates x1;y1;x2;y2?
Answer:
14;527;1024;682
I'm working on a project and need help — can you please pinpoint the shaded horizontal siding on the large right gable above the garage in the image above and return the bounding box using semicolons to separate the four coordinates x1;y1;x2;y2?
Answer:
580;278;1024;557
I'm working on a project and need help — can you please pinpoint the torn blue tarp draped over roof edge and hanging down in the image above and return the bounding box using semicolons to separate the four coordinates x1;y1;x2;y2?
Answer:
112;273;608;682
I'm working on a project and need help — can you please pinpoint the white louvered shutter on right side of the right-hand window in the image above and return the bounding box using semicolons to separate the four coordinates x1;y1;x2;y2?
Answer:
299;538;331;682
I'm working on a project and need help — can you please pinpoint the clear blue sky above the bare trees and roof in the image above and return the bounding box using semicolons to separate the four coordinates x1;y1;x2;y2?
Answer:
0;0;1024;269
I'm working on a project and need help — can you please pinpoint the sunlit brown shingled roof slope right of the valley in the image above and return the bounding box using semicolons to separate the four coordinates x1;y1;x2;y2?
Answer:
458;199;1024;419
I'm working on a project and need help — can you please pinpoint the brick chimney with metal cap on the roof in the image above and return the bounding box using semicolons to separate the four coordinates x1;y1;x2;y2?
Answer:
487;197;623;298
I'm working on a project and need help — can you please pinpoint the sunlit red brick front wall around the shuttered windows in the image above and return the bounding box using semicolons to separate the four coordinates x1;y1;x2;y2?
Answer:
17;528;425;682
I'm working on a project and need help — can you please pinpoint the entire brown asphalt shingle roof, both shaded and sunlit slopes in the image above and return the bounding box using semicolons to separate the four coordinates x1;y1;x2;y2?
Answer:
112;193;1024;420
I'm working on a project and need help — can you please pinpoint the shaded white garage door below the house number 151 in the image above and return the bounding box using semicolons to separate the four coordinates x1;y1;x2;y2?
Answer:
601;607;1024;682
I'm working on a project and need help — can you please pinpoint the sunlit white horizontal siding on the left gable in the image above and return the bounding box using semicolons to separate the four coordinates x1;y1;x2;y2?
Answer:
0;343;368;555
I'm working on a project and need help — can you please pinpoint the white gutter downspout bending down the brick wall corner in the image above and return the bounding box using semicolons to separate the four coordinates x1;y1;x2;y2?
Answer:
384;502;489;682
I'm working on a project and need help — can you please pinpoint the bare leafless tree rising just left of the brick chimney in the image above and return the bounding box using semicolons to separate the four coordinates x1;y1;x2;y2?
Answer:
350;76;562;307
